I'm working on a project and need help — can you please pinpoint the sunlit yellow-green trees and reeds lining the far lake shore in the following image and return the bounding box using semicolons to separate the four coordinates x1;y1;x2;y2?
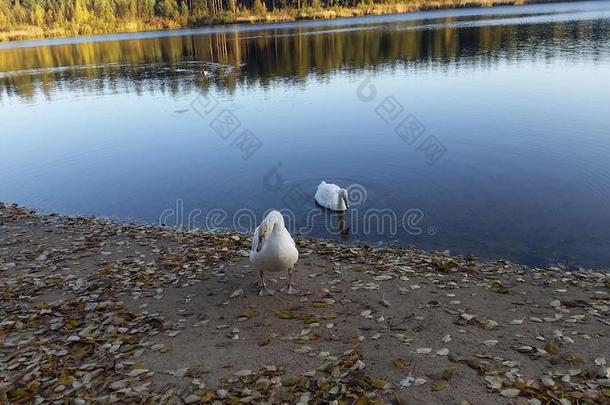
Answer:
0;0;553;42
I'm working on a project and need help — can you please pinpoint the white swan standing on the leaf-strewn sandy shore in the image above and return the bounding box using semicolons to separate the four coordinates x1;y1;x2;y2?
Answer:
250;210;299;296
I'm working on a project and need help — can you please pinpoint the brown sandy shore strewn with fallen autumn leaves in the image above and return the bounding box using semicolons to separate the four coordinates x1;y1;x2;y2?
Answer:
0;200;610;404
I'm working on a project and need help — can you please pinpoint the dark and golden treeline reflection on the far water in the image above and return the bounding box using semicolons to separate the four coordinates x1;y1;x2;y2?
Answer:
0;18;610;100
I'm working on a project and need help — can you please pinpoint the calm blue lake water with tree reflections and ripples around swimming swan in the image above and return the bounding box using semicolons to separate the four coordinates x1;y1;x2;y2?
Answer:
0;1;610;266
